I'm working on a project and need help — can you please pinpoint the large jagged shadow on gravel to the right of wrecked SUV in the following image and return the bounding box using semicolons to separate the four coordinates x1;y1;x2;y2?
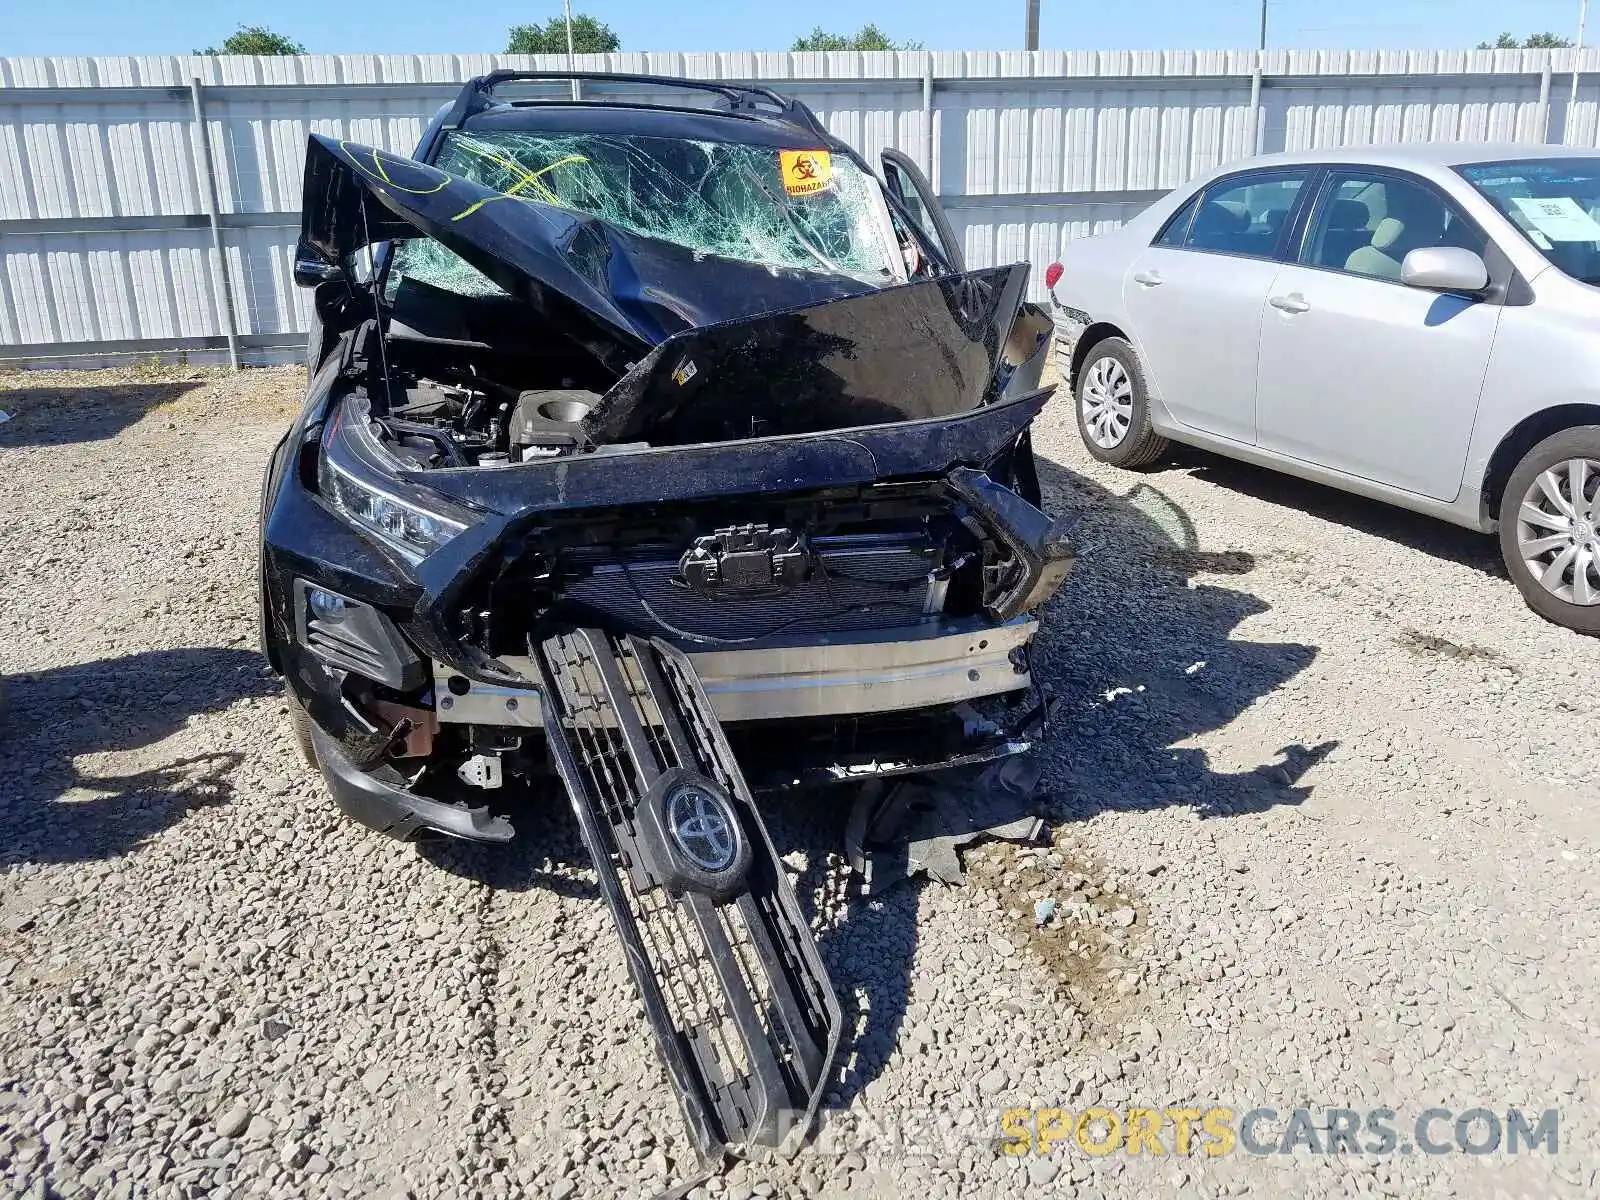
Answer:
1035;459;1338;818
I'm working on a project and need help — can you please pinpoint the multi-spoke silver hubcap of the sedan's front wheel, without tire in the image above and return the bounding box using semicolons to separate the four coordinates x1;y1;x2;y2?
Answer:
1517;458;1600;606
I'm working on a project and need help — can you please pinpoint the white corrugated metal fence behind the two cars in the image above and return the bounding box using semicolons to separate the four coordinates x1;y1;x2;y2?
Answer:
9;50;1600;363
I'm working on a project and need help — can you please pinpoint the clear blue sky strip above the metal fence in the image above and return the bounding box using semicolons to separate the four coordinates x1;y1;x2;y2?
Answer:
0;0;1600;56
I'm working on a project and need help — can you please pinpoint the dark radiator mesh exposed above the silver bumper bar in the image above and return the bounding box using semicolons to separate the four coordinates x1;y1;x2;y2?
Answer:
563;533;944;643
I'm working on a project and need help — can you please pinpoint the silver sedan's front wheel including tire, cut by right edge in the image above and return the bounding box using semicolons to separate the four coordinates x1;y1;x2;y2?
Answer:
1499;426;1600;637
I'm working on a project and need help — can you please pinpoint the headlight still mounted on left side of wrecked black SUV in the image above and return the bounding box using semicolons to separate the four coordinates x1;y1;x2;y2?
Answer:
317;397;475;563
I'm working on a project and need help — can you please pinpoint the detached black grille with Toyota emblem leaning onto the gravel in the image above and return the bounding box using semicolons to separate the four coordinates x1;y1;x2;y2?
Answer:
533;629;842;1157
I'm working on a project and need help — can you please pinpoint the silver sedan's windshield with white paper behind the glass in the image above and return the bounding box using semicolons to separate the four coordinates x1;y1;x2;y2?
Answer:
1458;158;1600;283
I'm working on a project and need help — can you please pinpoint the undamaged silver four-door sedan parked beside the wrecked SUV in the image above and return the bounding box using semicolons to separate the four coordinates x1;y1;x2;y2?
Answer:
1046;146;1600;634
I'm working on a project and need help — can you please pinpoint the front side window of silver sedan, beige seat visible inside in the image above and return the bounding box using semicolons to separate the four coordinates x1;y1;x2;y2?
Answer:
1304;171;1486;283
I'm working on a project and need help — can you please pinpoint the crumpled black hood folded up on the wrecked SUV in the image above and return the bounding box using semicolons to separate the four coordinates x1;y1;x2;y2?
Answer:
299;134;1048;445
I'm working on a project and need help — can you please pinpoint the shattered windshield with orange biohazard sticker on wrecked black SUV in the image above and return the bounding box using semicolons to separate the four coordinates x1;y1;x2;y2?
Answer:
425;131;899;286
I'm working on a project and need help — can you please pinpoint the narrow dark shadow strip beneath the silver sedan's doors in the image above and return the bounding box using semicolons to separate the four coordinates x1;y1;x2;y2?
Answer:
1173;446;1507;579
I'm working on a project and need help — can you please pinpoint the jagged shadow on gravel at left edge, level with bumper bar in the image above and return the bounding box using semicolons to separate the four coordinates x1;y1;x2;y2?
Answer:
0;646;275;867
